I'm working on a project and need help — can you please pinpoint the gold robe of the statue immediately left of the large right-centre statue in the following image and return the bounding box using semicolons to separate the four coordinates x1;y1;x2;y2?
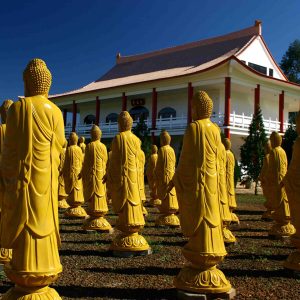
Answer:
155;145;178;213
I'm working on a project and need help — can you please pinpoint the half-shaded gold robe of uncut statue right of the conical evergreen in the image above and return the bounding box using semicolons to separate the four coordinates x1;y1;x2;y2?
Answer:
268;146;290;222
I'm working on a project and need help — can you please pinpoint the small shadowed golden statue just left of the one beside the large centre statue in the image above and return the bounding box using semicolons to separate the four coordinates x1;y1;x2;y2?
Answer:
146;145;161;206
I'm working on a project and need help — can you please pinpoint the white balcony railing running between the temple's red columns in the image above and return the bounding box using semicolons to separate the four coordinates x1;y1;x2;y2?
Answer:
65;112;289;137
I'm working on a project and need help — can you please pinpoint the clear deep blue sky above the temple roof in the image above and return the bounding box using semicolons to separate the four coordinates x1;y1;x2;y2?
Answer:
0;0;300;102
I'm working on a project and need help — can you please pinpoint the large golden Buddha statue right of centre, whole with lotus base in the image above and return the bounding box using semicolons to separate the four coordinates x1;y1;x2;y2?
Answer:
173;91;231;293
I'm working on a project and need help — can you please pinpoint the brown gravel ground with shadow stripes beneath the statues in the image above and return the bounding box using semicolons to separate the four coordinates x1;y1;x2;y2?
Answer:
0;194;300;300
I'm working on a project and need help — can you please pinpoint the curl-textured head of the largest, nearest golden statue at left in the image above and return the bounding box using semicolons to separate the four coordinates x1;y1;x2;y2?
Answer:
23;58;52;97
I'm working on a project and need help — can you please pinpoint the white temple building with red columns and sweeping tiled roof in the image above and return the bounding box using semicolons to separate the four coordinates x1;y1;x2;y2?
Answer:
50;21;300;156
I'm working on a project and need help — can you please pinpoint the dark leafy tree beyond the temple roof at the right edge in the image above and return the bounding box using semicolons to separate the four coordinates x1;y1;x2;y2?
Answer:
280;39;300;83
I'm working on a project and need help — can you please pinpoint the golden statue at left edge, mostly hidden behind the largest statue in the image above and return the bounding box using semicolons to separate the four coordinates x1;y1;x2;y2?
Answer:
0;100;14;264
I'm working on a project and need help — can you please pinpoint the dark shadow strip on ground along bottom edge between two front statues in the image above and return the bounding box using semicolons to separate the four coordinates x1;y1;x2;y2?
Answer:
54;286;177;299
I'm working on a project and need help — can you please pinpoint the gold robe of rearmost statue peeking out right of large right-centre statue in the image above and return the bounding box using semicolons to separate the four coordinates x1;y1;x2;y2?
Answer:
226;150;237;209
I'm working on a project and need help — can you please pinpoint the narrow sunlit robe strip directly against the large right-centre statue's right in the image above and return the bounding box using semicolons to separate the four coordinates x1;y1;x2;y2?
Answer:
218;143;231;222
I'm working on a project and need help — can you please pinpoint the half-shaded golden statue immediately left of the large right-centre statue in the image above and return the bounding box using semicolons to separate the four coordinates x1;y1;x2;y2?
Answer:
155;130;180;227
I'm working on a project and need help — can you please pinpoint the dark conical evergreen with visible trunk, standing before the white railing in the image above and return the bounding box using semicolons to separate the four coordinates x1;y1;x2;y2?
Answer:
241;107;267;195
